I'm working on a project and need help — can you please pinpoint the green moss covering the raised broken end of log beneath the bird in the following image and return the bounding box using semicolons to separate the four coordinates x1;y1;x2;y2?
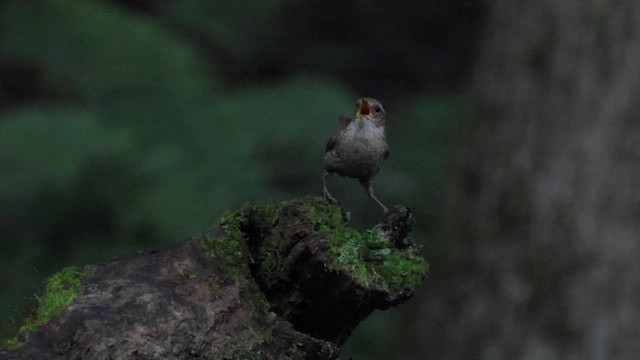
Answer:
202;197;427;352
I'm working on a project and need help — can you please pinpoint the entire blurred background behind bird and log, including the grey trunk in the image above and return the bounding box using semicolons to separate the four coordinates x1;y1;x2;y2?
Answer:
5;0;640;360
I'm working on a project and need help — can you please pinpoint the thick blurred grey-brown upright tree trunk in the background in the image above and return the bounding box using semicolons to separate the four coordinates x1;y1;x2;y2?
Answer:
408;0;640;359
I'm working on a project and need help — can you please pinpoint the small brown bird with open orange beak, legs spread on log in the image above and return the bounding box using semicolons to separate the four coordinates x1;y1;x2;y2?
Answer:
322;98;389;213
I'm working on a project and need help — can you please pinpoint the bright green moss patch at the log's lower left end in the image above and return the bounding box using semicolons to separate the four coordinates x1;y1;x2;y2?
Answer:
4;266;93;349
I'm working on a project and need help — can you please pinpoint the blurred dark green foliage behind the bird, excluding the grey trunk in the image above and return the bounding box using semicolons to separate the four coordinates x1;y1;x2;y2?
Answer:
0;0;478;359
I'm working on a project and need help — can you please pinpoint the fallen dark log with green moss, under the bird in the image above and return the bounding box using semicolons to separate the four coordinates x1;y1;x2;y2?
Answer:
0;197;426;359
